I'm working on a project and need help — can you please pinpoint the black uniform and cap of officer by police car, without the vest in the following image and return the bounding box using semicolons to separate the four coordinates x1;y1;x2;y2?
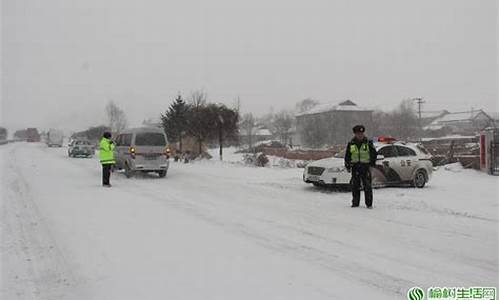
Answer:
344;125;377;208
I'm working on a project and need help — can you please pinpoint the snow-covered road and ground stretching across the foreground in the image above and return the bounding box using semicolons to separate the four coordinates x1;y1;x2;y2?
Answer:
0;143;498;300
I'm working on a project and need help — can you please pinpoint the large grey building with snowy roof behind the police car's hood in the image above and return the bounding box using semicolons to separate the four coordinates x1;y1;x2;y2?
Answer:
295;100;373;148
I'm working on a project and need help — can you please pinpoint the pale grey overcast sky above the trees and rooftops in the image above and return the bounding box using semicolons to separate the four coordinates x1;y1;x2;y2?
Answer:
0;0;499;129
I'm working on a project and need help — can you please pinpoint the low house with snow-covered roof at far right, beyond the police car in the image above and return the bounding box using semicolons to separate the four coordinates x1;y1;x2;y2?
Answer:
423;109;497;135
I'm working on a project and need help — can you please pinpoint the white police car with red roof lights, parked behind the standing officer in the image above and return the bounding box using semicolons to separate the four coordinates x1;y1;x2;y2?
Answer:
303;137;433;188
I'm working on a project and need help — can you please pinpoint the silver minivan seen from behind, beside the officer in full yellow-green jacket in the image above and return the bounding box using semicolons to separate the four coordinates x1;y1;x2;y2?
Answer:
115;127;170;178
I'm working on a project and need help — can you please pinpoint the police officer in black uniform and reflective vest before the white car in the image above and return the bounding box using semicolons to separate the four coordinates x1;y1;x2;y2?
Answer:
344;125;377;208
